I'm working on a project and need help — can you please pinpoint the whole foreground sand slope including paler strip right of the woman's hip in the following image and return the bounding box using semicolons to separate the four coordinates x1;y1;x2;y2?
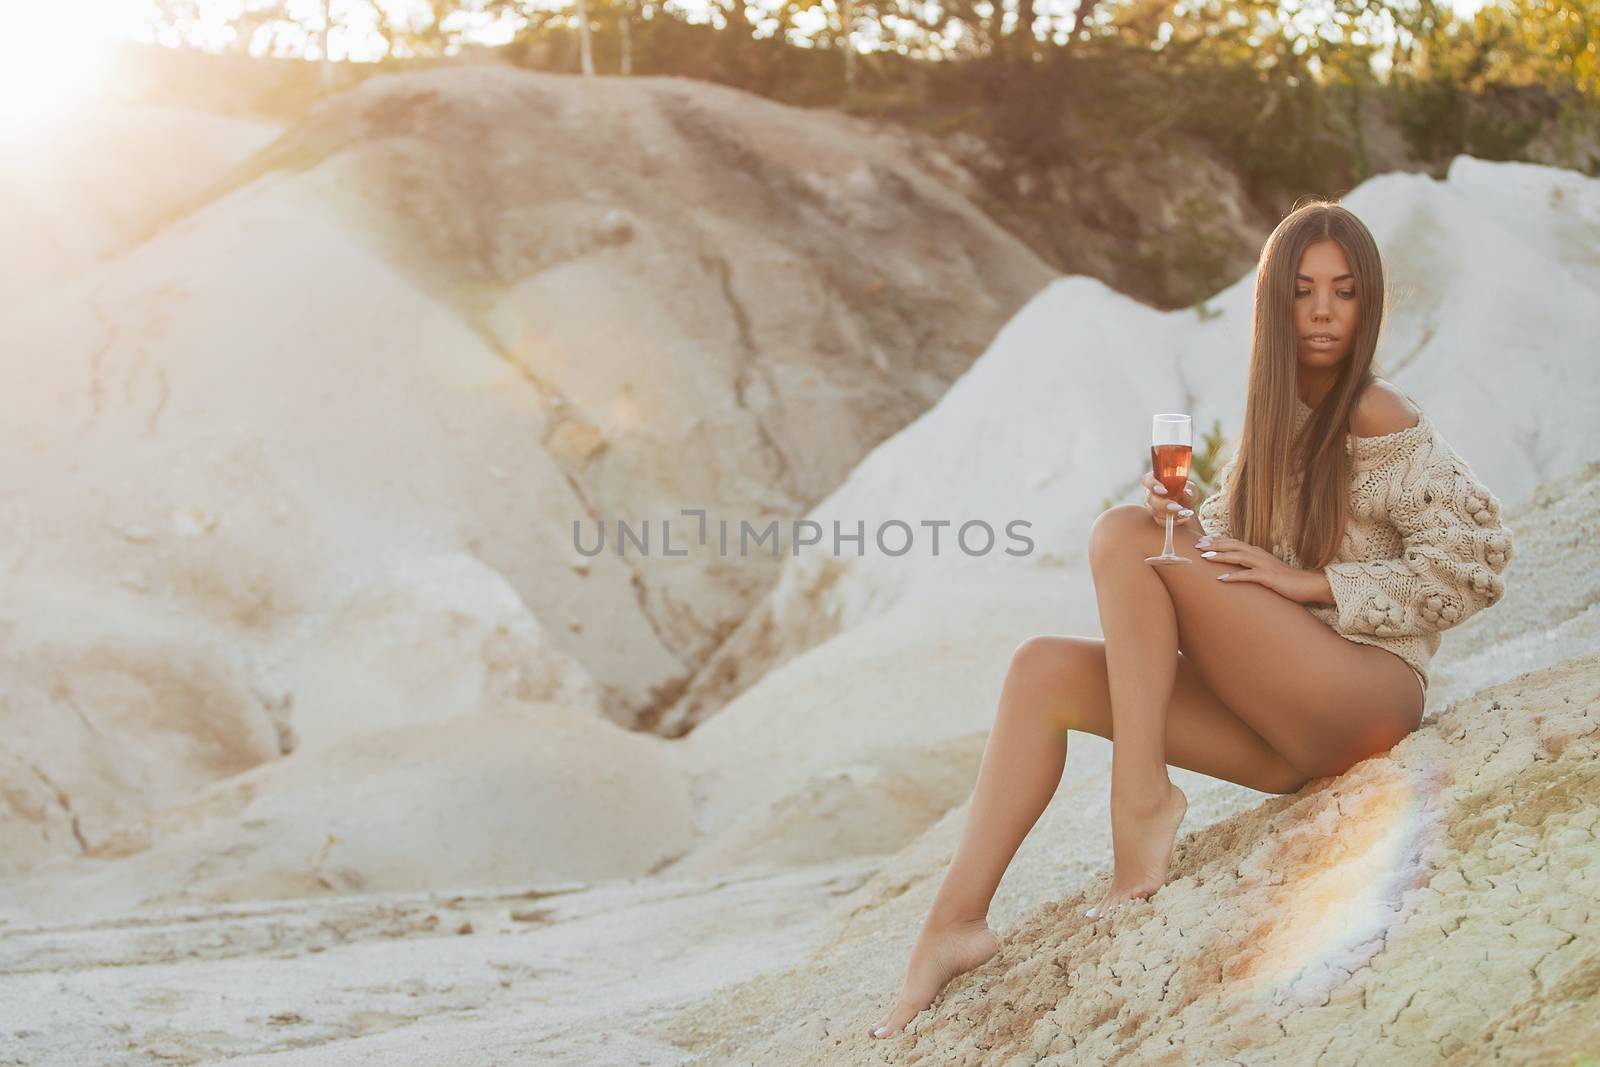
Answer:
658;447;1600;1064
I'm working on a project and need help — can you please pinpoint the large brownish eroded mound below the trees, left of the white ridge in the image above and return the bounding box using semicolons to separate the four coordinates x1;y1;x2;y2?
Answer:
222;67;1050;700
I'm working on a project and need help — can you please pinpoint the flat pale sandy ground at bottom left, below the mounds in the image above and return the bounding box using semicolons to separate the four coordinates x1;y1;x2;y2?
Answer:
0;859;872;1067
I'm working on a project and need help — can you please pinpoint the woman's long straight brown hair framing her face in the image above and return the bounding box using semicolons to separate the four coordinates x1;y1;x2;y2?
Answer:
1224;197;1386;568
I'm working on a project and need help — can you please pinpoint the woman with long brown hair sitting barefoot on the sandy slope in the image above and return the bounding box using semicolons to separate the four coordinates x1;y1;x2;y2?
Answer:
872;200;1512;1037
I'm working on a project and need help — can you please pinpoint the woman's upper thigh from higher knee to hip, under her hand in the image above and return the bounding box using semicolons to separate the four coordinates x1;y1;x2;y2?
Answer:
1098;506;1422;776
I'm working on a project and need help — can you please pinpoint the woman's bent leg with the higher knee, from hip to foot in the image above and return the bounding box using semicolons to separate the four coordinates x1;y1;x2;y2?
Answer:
1088;506;1422;917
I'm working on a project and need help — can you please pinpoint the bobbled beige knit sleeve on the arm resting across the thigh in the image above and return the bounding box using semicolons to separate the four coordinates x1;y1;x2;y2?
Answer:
1323;435;1512;637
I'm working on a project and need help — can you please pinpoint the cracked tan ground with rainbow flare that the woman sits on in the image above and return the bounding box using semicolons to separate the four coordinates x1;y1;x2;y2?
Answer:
656;654;1600;1067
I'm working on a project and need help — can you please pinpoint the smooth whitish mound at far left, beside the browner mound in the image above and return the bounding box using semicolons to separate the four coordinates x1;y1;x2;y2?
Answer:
0;181;624;876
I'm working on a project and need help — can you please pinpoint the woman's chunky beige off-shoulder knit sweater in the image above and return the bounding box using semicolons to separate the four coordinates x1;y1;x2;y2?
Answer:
1195;402;1512;694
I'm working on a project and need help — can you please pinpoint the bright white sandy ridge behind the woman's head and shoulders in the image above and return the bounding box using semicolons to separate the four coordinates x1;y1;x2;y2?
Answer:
662;157;1600;733
